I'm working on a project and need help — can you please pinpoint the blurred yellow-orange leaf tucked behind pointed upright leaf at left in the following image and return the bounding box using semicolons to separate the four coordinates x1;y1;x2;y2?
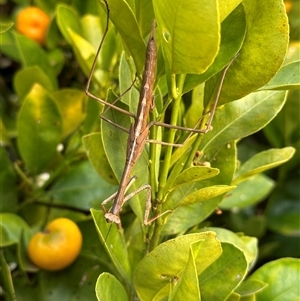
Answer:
53;89;87;138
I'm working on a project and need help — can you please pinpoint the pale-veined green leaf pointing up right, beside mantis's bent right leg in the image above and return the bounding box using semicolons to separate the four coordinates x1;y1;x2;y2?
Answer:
201;91;286;151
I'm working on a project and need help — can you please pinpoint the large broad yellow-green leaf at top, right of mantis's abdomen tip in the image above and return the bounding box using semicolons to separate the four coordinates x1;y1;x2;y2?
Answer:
153;0;220;74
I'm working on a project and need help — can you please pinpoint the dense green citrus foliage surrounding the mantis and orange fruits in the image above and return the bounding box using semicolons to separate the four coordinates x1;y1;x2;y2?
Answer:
0;0;300;301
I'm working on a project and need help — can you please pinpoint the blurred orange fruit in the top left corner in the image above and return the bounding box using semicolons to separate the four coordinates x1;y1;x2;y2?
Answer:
16;6;50;45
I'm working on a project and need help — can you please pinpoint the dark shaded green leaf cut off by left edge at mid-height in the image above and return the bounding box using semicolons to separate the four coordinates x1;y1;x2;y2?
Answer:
0;147;18;212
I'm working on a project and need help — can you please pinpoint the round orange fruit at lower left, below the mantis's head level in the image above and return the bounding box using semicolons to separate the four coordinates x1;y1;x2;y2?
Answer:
28;218;82;271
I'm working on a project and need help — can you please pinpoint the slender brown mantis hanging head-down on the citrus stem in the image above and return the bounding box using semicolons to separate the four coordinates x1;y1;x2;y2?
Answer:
86;1;238;225
